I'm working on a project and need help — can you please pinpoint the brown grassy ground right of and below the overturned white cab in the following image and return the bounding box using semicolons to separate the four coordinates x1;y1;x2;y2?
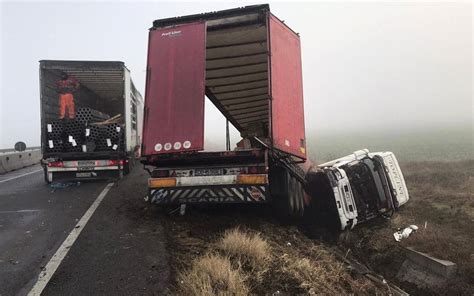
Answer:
343;161;474;295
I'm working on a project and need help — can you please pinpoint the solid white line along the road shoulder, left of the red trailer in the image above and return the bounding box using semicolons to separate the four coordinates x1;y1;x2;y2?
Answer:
28;183;114;296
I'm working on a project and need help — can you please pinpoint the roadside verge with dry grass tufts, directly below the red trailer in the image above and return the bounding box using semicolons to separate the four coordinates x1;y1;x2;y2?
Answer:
167;210;386;295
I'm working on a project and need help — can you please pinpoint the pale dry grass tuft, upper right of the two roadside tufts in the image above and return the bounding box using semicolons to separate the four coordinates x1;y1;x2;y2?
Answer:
217;228;271;278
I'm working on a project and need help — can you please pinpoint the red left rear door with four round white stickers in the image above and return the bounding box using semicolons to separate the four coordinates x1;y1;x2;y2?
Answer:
142;22;206;155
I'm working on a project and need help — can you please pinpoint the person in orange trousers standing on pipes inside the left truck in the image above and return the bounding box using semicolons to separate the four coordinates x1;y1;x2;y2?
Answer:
56;72;79;119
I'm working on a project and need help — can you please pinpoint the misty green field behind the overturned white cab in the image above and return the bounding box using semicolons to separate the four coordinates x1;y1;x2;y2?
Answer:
307;126;474;163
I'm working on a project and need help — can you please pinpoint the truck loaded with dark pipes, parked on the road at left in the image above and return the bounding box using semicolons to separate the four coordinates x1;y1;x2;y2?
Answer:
39;60;143;183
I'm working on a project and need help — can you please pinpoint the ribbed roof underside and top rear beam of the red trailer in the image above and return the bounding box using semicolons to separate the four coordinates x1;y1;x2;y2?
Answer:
150;4;270;132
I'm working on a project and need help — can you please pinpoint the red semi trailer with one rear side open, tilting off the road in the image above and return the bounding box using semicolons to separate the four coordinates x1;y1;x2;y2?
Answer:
142;5;306;217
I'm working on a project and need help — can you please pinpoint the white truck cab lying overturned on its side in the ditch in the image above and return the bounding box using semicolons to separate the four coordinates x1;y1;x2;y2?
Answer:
310;149;409;230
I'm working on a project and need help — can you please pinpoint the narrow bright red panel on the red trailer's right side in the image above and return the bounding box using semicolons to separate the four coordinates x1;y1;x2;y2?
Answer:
269;14;306;159
